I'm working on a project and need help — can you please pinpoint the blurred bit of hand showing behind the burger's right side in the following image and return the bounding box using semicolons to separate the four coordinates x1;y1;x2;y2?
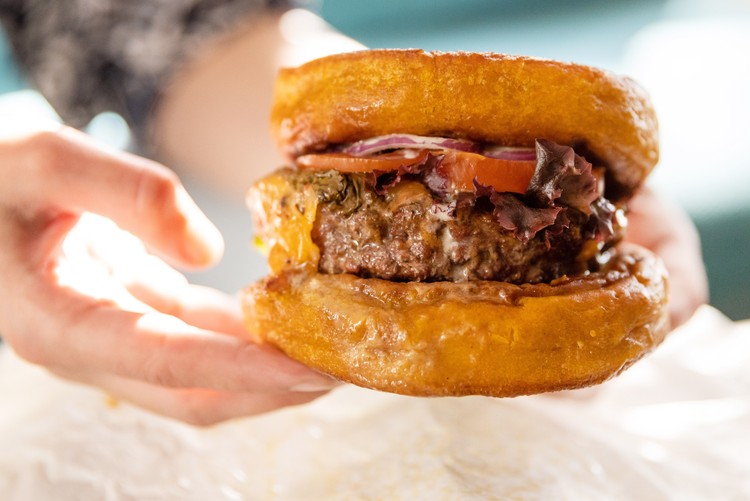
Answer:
626;188;708;328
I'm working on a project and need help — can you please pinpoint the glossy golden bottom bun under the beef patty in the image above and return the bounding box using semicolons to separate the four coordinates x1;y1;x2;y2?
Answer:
244;246;669;397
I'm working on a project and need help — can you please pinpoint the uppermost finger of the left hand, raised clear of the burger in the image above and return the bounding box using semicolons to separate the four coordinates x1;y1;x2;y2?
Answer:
6;128;223;267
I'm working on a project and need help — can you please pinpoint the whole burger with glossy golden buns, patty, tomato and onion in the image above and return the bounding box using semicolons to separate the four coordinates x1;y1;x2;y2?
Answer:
243;50;669;397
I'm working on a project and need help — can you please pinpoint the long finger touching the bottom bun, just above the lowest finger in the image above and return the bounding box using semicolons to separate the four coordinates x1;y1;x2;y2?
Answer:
12;280;334;393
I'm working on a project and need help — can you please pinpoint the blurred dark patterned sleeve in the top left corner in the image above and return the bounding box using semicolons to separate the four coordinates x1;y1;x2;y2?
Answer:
0;0;287;145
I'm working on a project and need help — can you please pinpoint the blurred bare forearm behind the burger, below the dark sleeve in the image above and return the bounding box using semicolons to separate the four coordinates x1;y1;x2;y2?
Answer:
153;11;361;196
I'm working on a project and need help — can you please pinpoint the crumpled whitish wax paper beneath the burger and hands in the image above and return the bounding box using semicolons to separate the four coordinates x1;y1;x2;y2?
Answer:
0;307;750;501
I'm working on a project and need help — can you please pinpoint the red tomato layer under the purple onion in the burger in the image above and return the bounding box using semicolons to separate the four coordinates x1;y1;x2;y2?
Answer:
297;149;536;193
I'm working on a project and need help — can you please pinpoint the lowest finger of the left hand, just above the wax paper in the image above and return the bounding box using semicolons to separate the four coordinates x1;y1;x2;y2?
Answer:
53;371;326;426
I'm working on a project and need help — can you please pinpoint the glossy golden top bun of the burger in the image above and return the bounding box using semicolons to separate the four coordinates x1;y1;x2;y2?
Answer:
271;50;658;191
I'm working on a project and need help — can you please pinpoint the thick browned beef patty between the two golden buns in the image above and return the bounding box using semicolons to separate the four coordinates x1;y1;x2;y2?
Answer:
287;170;622;284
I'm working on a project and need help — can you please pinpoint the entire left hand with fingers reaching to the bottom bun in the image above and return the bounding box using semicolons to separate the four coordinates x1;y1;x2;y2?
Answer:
0;126;332;425
